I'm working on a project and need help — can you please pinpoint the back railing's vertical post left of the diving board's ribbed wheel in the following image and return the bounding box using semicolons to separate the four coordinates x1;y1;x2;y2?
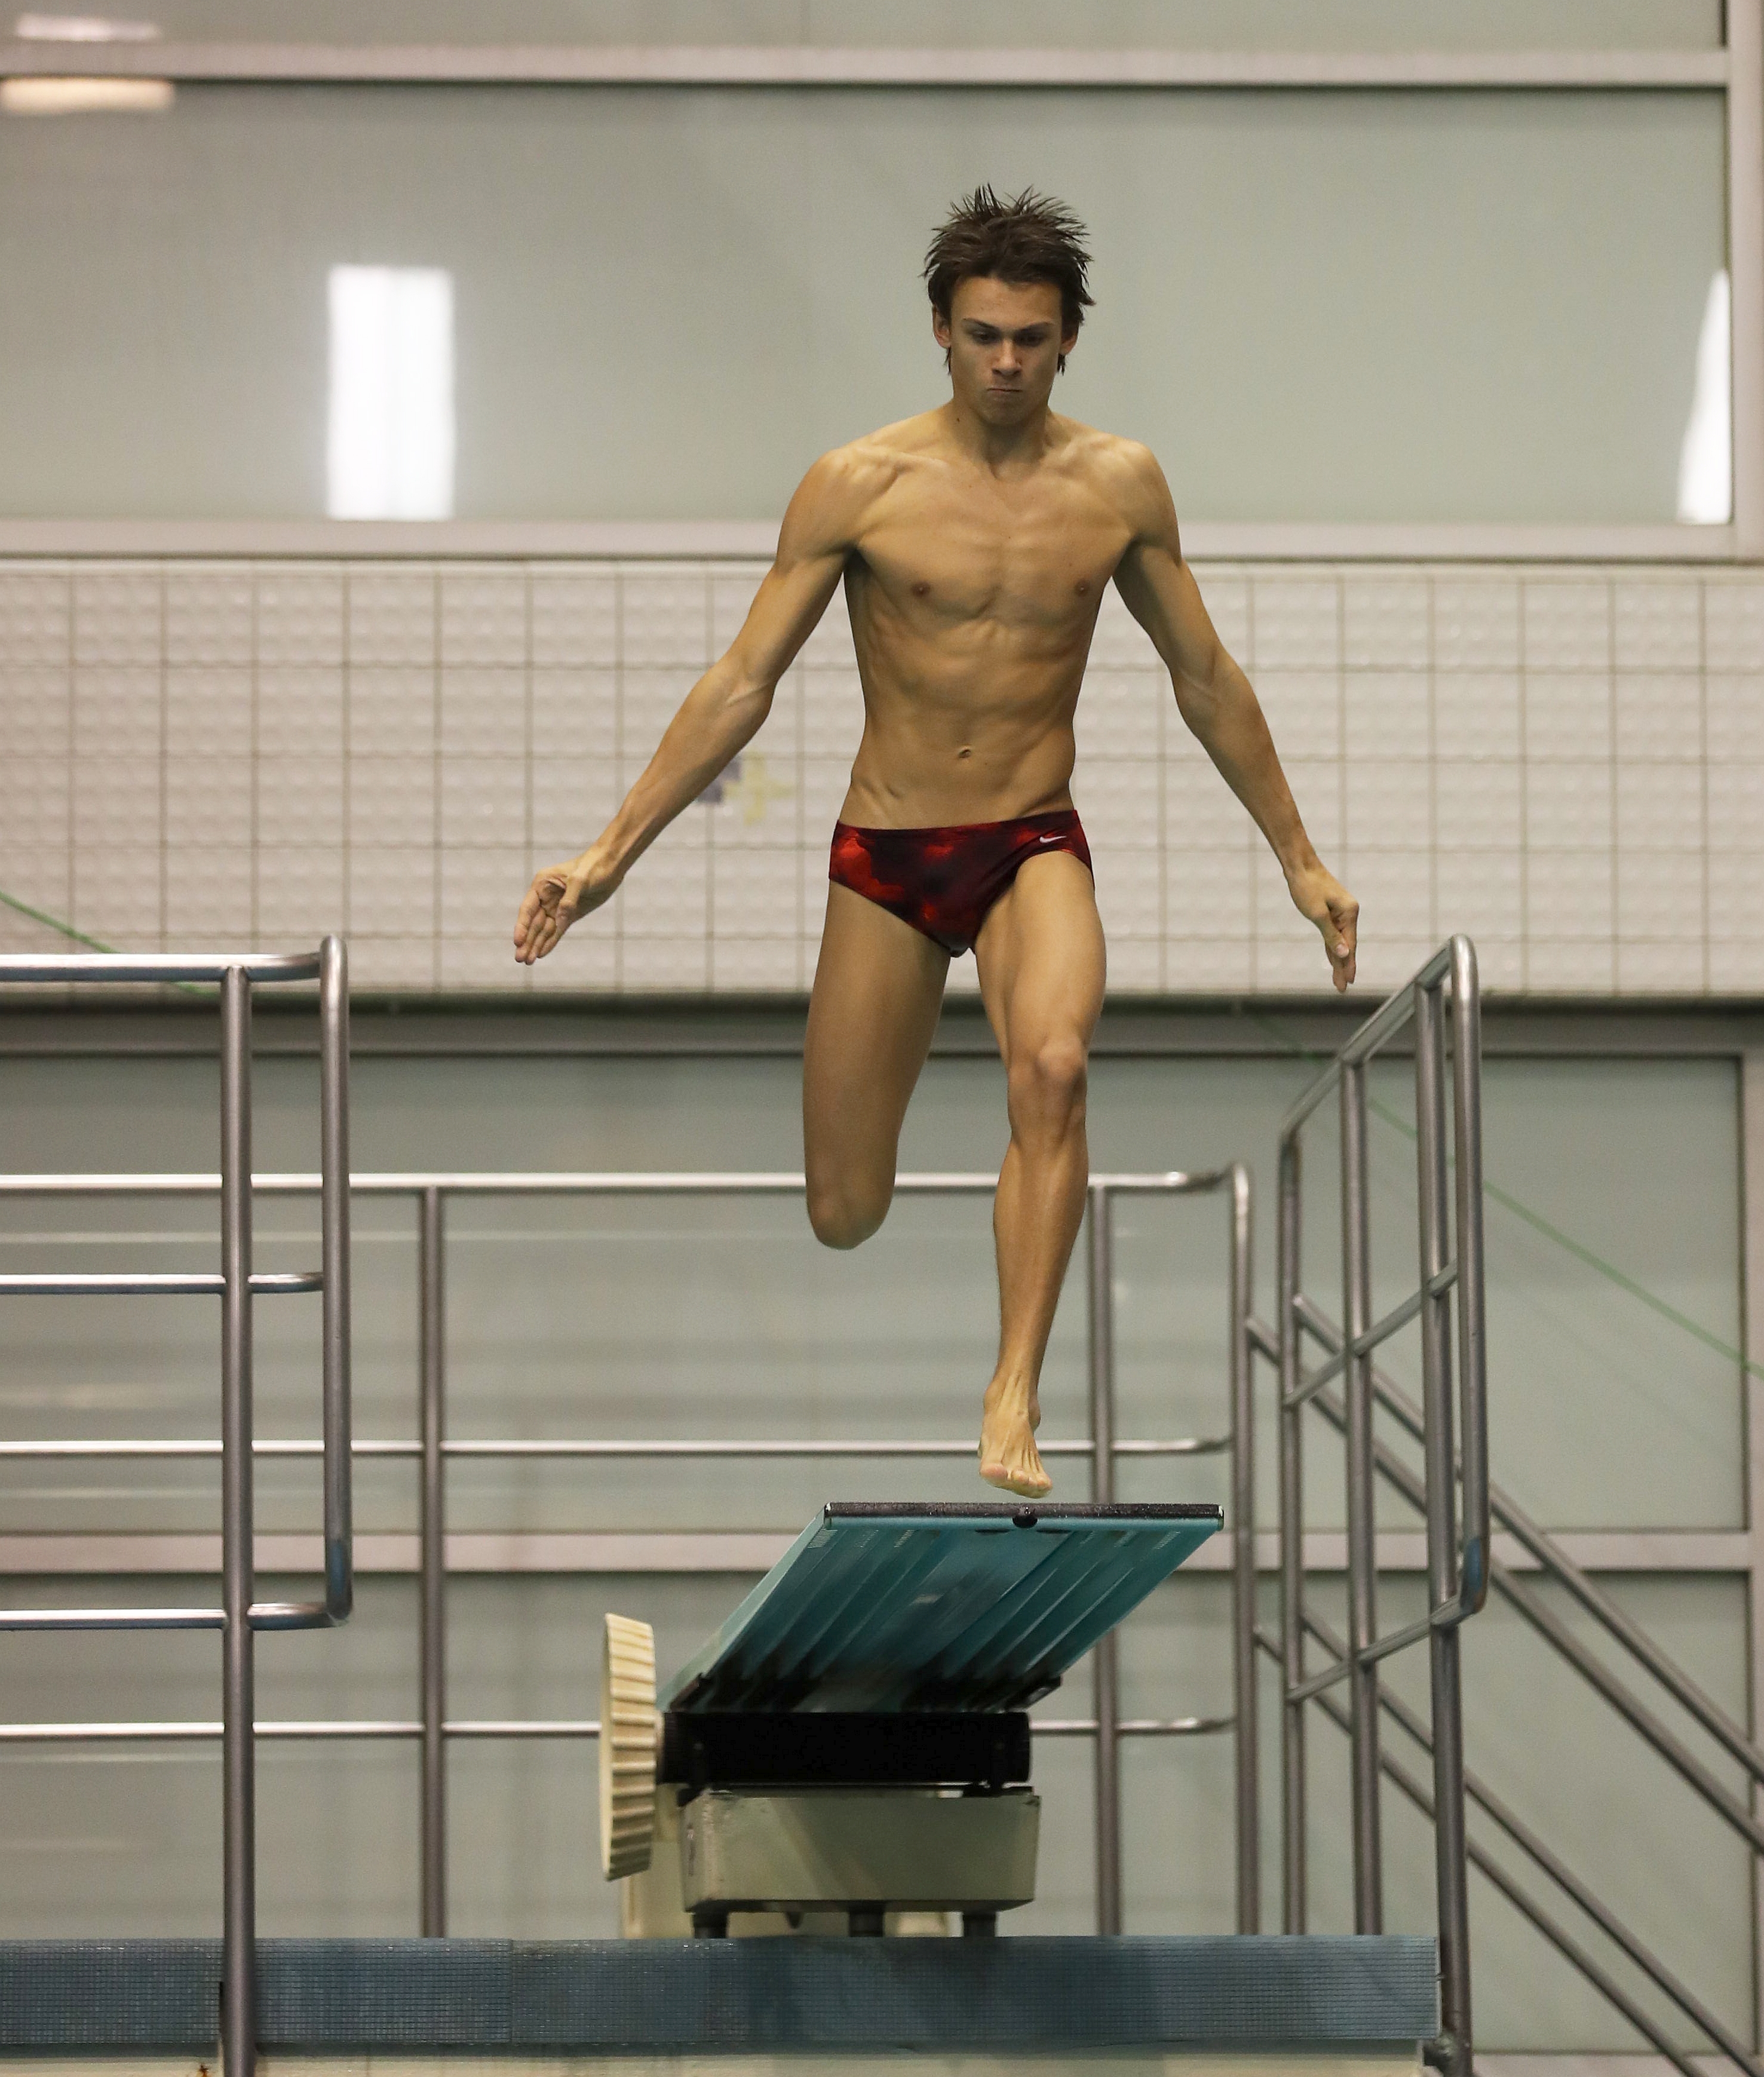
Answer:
418;1186;447;1938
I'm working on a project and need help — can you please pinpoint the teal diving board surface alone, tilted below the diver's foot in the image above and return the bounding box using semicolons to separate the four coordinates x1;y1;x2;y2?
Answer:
659;1499;1224;1711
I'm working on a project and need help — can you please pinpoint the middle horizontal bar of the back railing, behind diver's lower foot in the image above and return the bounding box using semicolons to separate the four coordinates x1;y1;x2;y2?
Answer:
0;1435;1232;1460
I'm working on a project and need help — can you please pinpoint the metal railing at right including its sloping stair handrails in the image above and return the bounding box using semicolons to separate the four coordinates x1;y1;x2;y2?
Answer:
1257;939;1764;2077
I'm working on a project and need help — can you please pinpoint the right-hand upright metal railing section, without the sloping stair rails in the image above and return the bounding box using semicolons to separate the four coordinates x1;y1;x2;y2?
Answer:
1278;937;1490;2077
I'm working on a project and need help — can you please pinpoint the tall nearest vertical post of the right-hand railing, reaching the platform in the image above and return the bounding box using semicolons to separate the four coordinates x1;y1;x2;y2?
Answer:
1415;983;1471;2077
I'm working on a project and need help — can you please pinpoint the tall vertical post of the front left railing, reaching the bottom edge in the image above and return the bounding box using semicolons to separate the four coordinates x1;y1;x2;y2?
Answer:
220;966;257;2077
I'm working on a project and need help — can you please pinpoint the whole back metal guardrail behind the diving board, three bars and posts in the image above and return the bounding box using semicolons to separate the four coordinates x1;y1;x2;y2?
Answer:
0;1165;1276;1969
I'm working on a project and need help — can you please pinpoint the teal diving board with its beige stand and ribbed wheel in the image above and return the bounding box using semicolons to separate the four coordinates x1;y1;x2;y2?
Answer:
599;1512;1222;1938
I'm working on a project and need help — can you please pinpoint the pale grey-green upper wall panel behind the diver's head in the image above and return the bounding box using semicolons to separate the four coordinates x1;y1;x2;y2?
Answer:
0;87;1725;521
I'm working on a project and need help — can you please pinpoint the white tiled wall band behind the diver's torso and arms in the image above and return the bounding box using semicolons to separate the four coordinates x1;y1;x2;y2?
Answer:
0;563;1764;997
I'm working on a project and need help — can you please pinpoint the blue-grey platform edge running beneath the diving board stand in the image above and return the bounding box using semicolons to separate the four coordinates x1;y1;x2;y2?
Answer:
0;1934;1438;2077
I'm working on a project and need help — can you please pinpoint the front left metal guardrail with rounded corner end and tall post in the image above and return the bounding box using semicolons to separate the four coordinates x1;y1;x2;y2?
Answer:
0;937;355;2077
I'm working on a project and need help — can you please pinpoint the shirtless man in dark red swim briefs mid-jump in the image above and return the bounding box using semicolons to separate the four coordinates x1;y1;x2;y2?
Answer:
516;187;1359;1498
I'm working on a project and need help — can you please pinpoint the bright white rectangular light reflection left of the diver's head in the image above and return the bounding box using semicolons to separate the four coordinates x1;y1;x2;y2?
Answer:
326;266;453;519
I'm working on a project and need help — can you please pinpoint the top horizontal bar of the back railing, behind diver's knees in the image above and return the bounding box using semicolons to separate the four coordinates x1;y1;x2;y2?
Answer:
0;1171;1230;1197
